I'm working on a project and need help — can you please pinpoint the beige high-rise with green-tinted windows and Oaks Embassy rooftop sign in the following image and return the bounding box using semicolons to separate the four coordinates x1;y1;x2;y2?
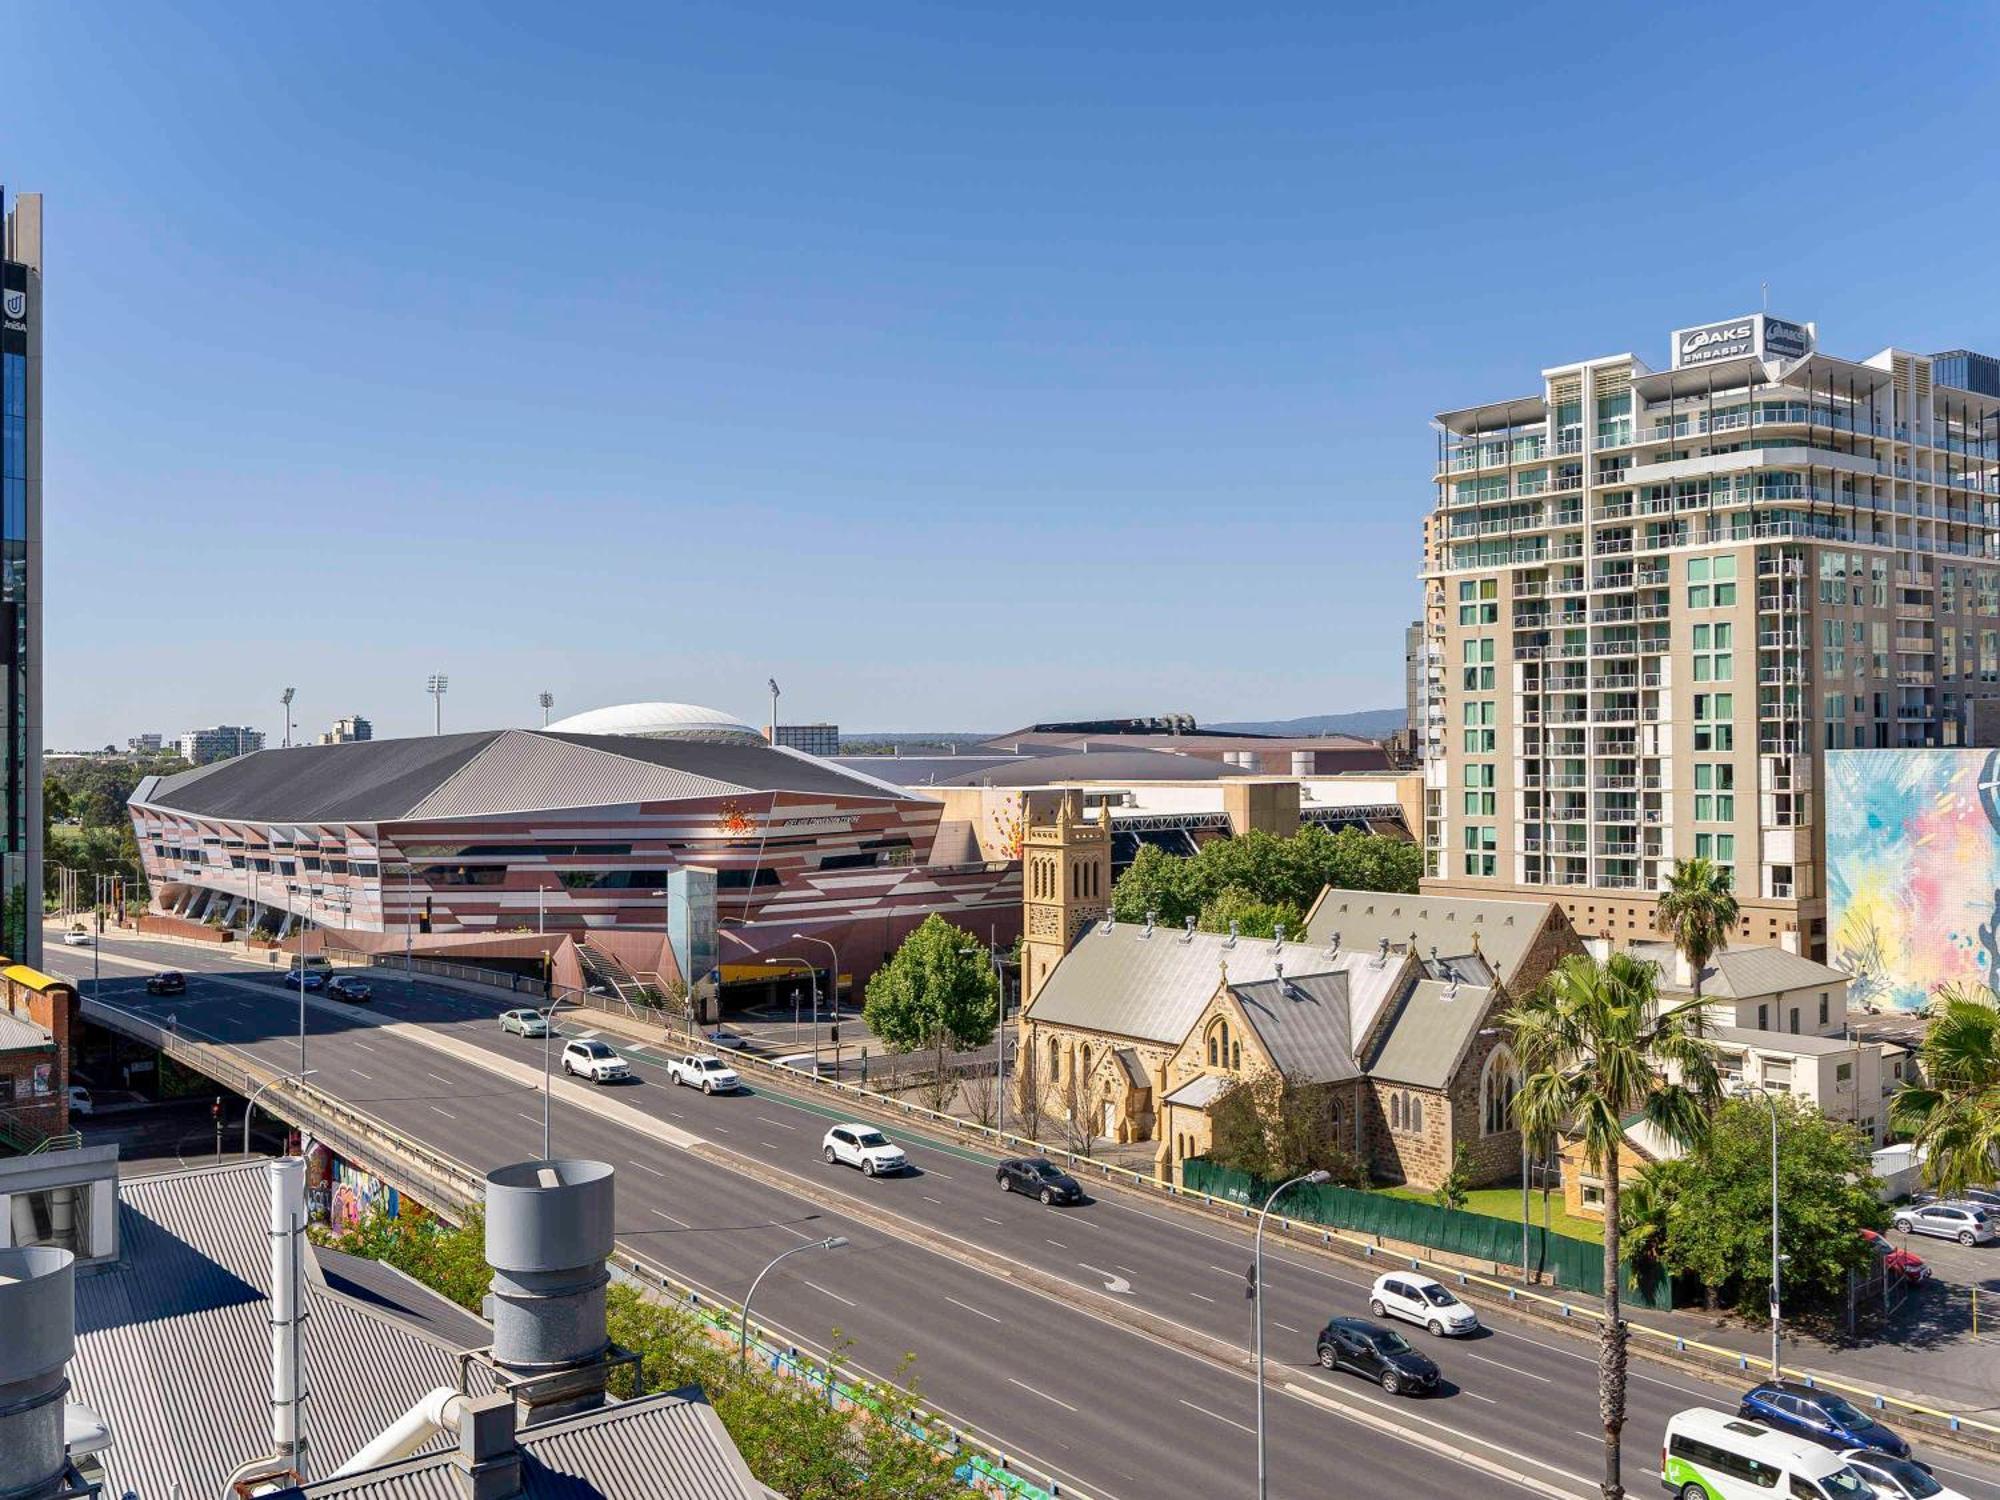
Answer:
1424;314;2000;956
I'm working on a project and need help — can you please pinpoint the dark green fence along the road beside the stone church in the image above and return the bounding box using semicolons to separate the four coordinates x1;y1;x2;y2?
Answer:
1180;1158;1674;1308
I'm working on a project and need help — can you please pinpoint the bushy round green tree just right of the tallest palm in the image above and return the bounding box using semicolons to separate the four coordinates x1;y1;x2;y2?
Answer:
1660;1096;1888;1314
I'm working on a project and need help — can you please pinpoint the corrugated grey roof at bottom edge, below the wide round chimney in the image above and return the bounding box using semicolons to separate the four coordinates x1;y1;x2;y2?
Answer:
278;1390;770;1500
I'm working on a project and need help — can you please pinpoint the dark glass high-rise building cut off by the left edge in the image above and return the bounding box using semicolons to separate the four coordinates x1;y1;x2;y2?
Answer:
0;190;42;964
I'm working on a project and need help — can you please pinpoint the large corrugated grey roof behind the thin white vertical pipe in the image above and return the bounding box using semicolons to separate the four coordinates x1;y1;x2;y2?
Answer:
70;1162;490;1500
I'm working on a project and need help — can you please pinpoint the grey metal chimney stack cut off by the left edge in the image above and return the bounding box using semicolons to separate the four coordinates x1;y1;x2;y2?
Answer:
0;1246;76;1500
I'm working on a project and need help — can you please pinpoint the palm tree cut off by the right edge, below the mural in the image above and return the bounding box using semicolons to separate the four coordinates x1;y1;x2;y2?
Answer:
1888;984;2000;1194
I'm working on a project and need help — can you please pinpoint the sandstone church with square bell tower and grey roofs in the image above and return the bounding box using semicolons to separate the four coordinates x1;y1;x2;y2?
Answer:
1016;790;1584;1188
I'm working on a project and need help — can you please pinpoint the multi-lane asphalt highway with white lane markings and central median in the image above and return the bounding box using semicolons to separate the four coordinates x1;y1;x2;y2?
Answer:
52;942;2000;1500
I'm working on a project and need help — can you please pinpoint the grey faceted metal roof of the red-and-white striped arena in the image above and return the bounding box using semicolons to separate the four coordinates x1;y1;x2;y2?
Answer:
134;730;902;824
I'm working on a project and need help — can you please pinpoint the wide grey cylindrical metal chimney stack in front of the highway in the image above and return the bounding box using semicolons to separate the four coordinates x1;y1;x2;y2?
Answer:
486;1160;614;1422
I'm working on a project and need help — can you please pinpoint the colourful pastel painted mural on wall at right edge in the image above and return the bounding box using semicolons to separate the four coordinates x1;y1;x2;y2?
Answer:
1826;750;2000;1010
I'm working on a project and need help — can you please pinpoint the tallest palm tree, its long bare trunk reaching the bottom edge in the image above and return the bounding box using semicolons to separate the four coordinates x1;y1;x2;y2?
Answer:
1502;952;1720;1500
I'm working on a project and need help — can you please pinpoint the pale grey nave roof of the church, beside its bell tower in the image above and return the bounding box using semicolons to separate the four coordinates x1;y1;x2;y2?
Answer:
1028;922;1334;1046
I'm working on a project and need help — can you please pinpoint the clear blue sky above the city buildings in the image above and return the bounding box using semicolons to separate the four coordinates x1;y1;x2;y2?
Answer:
15;0;2000;746
